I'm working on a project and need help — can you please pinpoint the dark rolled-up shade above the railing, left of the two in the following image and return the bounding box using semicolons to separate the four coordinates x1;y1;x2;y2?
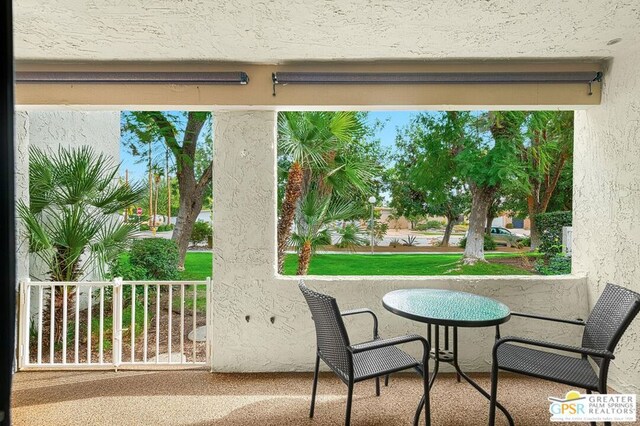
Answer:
16;71;249;84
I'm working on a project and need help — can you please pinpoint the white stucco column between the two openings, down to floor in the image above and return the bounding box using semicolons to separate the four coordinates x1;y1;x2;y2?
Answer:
212;111;276;371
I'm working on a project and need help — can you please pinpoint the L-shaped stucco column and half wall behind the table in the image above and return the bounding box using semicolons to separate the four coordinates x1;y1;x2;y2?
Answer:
213;111;587;371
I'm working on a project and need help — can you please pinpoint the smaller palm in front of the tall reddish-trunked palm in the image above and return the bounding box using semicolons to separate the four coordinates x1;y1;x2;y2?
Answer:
291;188;365;275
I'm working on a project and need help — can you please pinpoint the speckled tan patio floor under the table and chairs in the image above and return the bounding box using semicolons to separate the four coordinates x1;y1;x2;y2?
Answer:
13;370;592;426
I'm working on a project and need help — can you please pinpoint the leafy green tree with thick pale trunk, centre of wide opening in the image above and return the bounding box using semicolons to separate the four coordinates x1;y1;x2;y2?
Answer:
392;111;526;264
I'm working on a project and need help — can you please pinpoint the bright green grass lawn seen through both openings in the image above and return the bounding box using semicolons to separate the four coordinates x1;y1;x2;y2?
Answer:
174;252;531;280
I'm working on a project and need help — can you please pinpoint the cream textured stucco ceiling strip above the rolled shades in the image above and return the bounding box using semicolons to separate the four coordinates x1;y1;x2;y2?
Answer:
14;0;640;62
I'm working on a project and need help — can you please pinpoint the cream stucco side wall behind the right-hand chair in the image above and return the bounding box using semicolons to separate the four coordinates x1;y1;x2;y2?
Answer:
573;50;640;393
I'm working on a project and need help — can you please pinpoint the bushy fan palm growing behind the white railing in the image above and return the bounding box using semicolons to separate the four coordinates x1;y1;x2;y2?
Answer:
17;146;145;339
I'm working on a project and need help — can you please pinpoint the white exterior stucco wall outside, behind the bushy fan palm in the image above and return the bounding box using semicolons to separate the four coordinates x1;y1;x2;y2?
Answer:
15;110;120;280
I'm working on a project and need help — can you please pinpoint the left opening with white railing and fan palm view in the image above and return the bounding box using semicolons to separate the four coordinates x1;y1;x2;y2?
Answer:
17;110;213;367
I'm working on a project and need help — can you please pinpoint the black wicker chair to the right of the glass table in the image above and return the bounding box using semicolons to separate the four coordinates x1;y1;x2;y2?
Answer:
489;284;640;425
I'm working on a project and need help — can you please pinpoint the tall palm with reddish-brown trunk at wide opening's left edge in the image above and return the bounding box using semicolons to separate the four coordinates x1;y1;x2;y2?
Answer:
278;111;363;273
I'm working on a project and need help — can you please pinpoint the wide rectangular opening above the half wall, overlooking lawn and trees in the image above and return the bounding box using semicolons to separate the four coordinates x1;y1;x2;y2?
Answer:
277;110;573;275
